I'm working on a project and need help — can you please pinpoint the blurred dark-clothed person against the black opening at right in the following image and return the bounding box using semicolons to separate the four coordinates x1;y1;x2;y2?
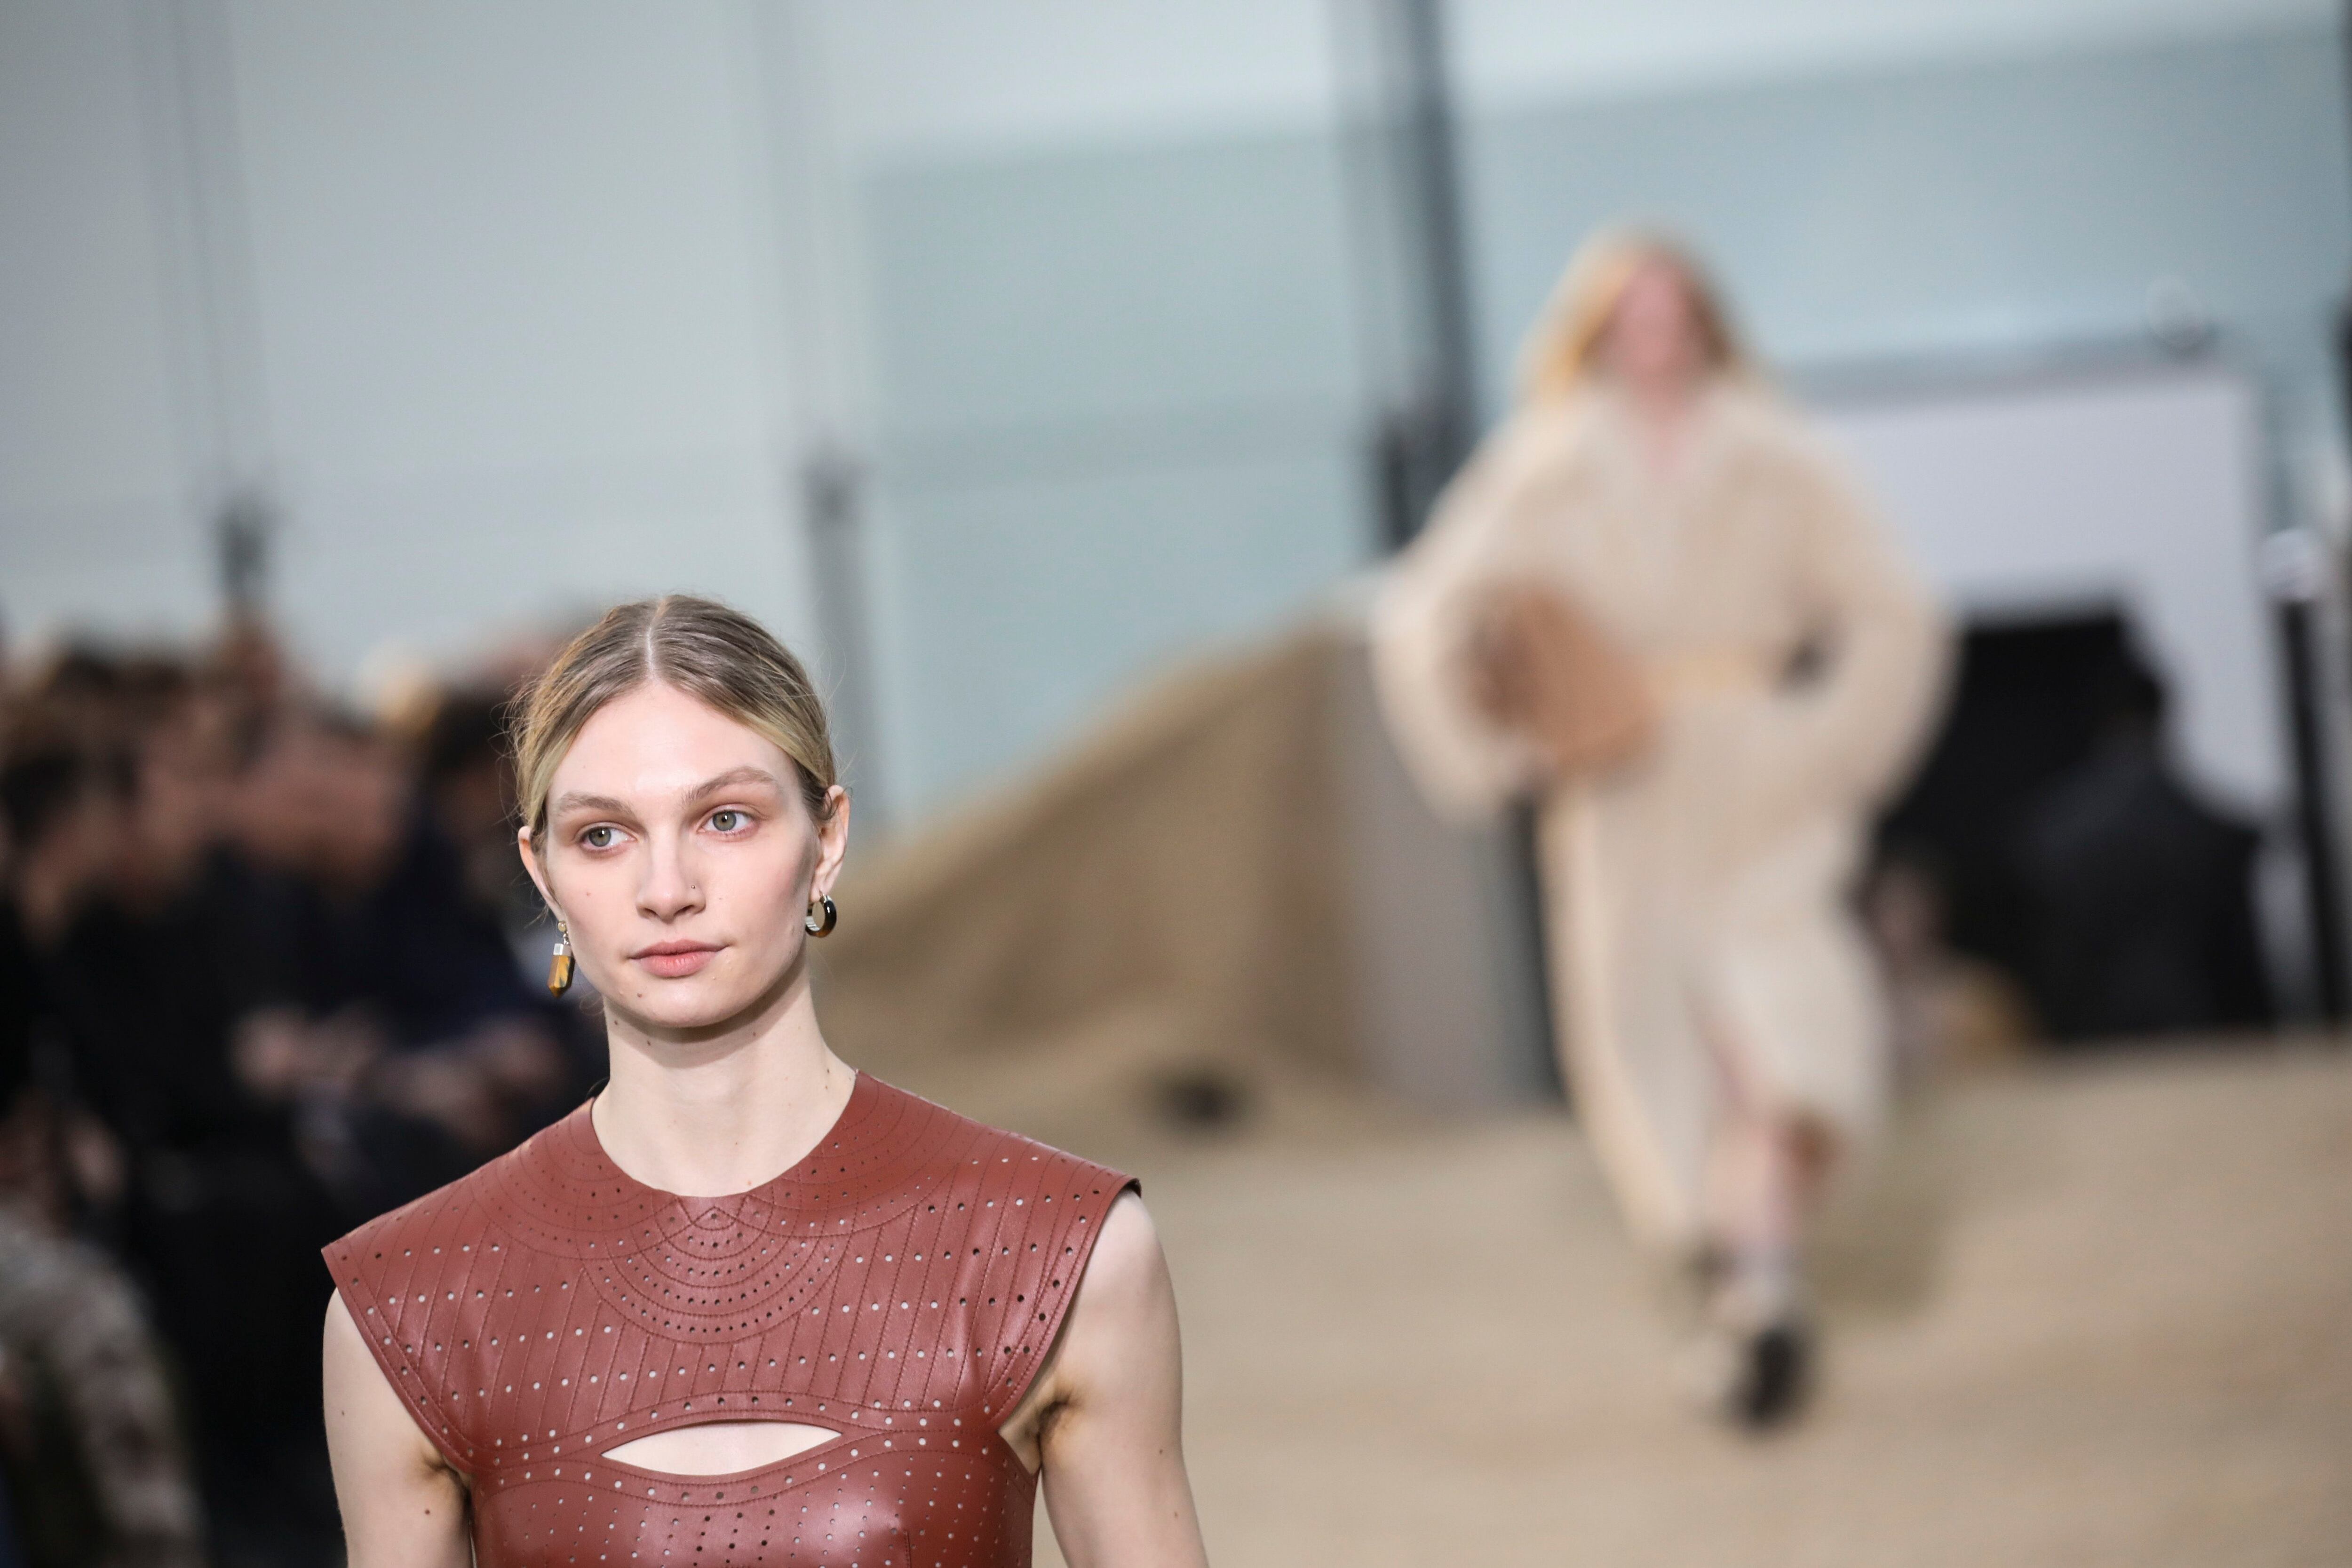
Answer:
2016;663;2274;1041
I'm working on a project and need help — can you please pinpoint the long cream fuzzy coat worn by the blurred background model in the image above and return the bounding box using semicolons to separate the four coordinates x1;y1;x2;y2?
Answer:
1374;381;1947;1248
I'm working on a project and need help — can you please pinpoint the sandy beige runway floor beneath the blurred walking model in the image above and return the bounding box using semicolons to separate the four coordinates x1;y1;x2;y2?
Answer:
1040;1046;2352;1568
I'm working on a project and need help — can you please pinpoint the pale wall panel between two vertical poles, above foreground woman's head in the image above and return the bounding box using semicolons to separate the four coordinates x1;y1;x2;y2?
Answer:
233;0;804;686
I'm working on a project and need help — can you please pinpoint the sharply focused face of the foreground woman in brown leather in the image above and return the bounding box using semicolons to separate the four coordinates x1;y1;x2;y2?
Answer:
522;682;849;1034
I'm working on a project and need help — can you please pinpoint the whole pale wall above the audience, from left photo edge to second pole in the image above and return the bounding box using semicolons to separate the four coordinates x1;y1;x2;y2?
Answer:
0;0;809;680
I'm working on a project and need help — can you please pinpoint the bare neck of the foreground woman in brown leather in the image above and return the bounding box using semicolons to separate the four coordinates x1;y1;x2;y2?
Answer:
588;975;856;1196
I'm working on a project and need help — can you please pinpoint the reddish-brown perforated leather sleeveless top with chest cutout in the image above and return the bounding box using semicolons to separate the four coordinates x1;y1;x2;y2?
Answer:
327;1074;1131;1568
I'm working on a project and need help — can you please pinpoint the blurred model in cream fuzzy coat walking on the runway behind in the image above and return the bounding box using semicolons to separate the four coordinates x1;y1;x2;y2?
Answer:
1376;235;1947;1425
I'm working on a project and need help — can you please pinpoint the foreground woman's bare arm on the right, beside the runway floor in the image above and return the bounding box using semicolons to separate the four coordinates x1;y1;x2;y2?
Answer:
1002;1192;1209;1568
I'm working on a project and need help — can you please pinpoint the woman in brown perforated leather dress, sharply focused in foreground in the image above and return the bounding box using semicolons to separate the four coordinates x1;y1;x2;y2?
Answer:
327;597;1204;1568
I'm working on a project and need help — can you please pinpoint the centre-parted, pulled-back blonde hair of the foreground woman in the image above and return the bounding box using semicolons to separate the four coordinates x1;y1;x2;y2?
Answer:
513;593;837;851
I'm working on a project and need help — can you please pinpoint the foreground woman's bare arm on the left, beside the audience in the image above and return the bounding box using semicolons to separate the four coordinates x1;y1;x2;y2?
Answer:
325;1298;473;1568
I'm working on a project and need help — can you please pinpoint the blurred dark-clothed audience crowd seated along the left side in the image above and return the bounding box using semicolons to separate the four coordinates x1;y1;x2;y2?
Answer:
0;626;602;1568
